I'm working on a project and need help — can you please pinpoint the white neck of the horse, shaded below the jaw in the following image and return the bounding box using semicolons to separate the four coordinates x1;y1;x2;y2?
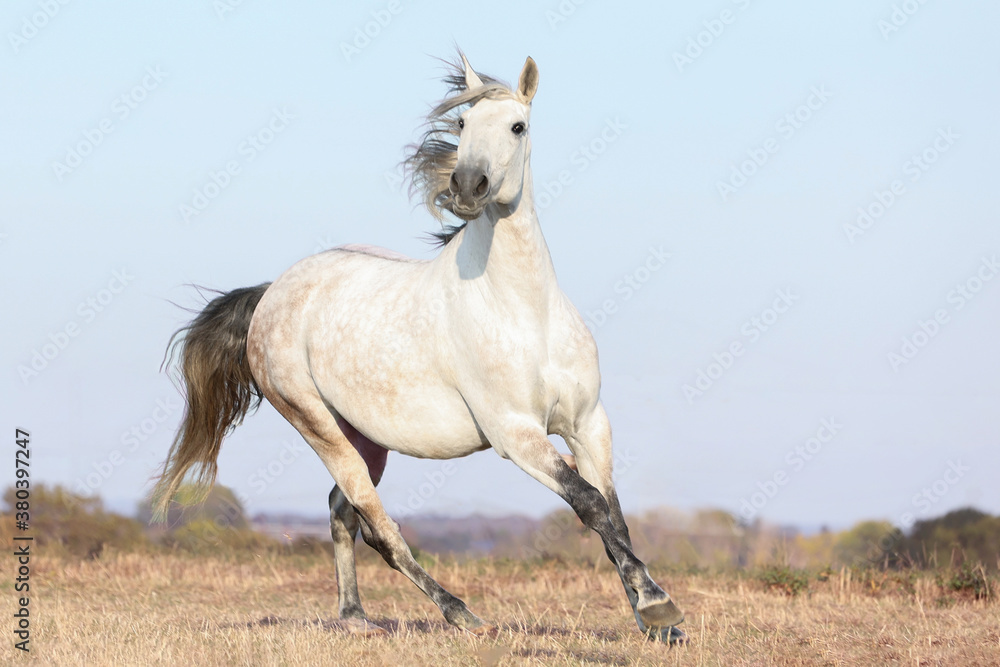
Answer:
456;165;559;312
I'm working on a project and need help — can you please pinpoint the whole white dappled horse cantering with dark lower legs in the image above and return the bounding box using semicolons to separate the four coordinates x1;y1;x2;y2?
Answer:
154;55;684;643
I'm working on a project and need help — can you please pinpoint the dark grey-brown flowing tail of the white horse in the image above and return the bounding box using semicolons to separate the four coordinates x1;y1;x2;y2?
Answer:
152;283;270;521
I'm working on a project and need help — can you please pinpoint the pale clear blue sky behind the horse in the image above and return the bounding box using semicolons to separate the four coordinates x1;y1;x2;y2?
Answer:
0;0;1000;526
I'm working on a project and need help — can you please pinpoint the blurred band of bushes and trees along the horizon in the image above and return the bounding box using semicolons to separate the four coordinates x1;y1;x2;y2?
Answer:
0;485;1000;576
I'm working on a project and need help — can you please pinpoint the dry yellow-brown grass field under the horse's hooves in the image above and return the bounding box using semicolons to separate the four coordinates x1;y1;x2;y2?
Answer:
9;552;1000;666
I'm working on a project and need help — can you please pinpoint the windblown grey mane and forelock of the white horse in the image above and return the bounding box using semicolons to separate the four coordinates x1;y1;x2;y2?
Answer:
403;52;517;245
